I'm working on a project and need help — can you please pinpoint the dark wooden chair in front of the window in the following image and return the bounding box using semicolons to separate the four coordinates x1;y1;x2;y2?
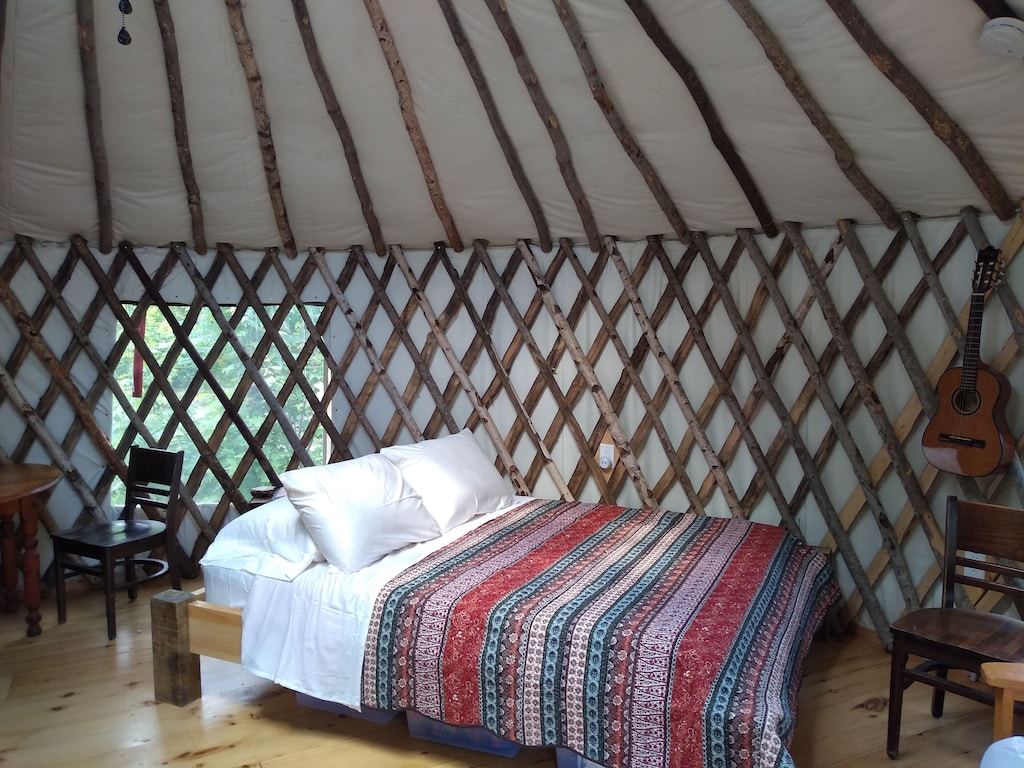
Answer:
52;445;184;640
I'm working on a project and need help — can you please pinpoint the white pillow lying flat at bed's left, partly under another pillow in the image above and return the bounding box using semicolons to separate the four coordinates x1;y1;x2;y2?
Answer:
201;498;324;581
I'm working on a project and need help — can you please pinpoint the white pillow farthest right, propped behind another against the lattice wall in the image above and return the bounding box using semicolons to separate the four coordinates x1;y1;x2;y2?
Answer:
381;429;512;532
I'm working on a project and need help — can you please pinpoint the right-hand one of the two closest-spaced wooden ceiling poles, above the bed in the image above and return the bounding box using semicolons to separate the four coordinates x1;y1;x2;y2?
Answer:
484;0;601;253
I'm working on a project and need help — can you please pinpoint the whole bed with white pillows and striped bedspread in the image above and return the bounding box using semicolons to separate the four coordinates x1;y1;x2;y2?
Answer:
154;432;839;768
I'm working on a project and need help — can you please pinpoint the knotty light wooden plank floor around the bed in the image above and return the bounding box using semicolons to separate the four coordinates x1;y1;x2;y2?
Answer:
0;580;1007;768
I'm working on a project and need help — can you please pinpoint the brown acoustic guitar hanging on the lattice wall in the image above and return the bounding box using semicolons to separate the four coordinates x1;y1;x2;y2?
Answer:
921;246;1014;477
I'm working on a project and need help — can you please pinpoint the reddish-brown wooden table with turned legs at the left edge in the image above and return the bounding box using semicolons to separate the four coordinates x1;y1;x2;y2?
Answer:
0;464;61;637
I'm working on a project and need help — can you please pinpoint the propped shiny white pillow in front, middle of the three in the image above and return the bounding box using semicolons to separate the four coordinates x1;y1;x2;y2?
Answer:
281;454;441;573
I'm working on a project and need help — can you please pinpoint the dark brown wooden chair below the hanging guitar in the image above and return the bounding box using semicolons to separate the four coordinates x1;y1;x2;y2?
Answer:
886;496;1024;760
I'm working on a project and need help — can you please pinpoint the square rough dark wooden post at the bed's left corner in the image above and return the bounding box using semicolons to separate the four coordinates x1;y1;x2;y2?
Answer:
150;590;203;707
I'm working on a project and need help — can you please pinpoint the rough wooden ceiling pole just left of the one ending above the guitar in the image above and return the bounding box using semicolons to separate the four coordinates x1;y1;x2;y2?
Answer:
729;0;899;229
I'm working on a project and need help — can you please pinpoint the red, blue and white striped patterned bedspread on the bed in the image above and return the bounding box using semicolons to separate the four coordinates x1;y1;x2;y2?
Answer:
362;501;839;768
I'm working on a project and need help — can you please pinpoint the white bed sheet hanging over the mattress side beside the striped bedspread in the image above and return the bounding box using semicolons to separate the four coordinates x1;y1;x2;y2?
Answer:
203;497;528;710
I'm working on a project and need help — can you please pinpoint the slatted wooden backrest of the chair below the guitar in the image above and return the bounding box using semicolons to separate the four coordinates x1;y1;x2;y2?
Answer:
942;496;1024;607
